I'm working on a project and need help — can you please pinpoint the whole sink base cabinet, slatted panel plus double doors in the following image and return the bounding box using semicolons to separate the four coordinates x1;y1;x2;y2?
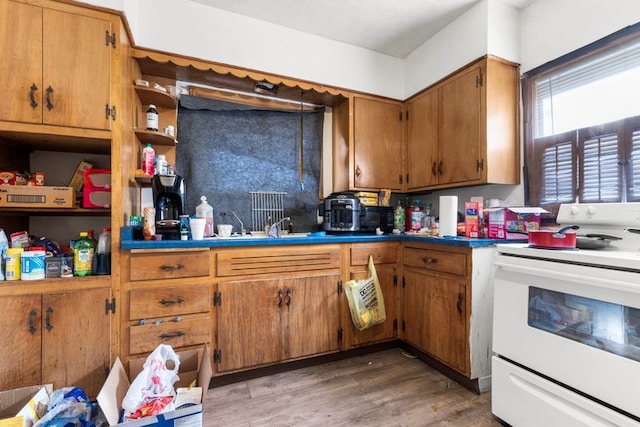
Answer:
214;244;342;374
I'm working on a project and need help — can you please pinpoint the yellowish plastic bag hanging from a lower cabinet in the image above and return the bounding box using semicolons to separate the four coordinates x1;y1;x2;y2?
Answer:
344;256;387;331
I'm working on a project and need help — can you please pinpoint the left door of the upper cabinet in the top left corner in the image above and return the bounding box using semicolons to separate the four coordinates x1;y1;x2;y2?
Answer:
0;0;42;123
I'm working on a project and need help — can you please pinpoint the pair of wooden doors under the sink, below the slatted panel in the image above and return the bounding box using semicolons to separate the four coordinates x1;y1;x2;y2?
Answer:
216;273;340;373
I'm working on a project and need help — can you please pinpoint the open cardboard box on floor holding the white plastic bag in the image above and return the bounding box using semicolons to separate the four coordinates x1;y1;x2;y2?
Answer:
98;346;213;427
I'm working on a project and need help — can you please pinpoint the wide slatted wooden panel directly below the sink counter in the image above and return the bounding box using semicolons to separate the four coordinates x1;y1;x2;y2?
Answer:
216;245;340;276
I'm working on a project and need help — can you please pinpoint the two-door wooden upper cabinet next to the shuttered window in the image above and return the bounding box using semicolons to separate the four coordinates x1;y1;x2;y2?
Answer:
405;57;520;191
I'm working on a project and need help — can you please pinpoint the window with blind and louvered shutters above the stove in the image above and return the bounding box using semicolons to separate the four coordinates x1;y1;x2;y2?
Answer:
523;24;640;213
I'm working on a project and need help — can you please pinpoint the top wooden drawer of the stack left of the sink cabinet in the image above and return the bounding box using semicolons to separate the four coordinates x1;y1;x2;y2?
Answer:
129;250;209;281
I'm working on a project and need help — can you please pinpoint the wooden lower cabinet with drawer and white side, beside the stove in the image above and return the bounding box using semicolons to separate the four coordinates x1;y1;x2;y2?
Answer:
399;242;494;391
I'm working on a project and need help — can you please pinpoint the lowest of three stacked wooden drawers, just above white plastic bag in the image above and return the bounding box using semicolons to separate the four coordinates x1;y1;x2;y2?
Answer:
129;317;211;354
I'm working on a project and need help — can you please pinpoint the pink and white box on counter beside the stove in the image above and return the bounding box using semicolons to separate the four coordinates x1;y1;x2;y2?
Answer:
486;207;548;239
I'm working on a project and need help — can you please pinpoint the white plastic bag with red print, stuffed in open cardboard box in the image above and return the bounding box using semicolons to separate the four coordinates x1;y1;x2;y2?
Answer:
122;344;180;419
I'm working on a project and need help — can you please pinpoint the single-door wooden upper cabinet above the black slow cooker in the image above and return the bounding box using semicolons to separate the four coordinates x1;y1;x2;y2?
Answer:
333;96;403;191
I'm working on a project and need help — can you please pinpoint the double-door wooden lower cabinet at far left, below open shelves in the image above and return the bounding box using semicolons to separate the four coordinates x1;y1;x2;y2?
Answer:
0;288;111;397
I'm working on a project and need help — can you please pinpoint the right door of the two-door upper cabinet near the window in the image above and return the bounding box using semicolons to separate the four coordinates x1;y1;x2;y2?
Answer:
438;67;484;184
